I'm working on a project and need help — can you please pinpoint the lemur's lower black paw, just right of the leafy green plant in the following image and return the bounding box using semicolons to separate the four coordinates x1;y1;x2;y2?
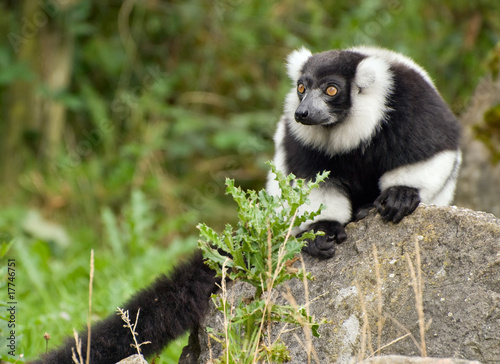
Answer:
302;221;347;259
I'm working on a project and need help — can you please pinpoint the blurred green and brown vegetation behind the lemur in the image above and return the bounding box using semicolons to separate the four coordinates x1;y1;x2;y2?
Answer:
0;0;500;363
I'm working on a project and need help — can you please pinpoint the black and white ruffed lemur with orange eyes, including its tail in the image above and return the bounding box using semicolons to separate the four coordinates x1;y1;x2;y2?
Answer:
31;47;461;364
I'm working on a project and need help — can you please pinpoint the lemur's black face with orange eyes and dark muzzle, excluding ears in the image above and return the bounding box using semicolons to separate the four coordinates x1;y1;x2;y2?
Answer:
295;51;362;126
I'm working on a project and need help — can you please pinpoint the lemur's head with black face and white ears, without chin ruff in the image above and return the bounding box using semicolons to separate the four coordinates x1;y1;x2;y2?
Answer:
287;48;390;126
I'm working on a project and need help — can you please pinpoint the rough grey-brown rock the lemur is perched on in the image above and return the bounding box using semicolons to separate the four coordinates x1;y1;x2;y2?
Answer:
193;205;500;364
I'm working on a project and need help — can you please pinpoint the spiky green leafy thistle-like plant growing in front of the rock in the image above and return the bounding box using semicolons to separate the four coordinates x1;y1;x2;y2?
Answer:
198;166;328;363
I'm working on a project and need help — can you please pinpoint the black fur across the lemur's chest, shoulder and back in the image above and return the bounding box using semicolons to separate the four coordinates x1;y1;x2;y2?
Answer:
284;67;460;211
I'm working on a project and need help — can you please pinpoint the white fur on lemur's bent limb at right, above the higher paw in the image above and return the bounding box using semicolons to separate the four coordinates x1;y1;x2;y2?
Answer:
379;150;462;205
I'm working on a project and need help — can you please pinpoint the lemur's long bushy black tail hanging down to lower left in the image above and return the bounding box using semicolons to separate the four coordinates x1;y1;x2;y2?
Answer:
32;252;217;364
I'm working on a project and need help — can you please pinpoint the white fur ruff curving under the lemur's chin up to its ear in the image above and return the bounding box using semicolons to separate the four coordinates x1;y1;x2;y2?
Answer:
285;52;393;155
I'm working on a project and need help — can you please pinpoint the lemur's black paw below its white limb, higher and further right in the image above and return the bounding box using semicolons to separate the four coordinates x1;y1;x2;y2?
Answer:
373;186;420;223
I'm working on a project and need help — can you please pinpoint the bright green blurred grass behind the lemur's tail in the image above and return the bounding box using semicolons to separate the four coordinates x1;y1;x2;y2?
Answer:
0;191;197;364
